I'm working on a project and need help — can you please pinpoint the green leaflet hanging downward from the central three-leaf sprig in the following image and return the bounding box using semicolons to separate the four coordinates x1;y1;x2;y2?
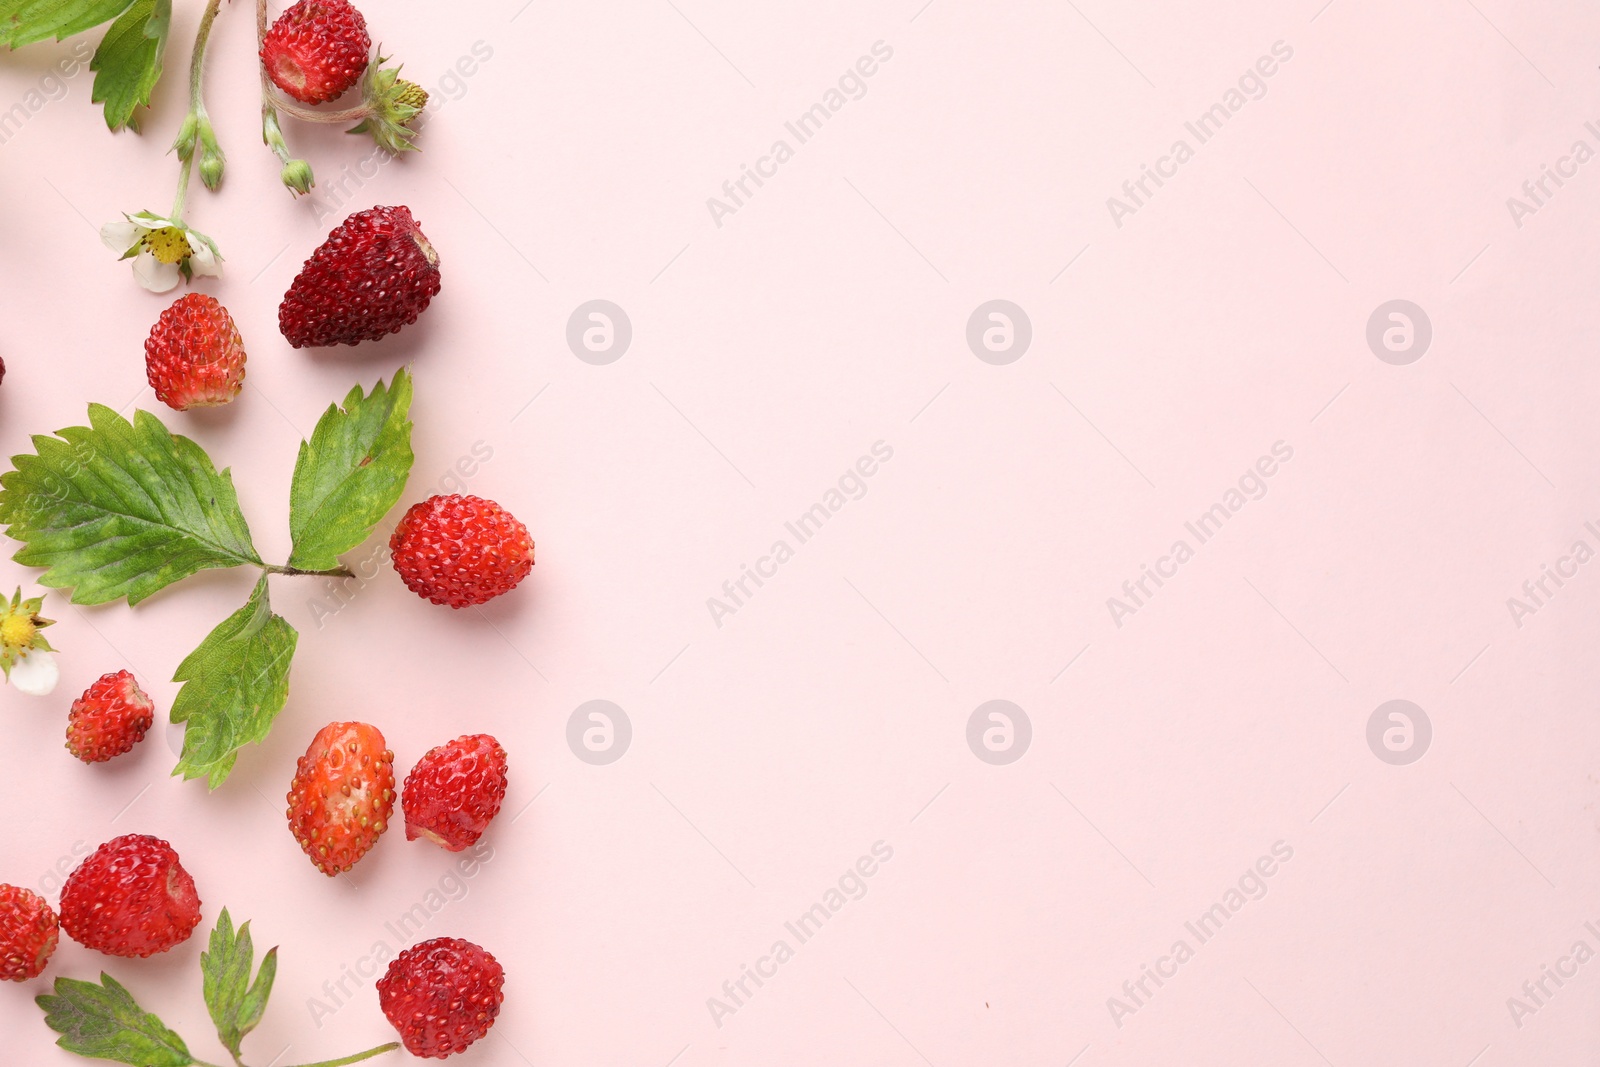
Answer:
173;574;299;789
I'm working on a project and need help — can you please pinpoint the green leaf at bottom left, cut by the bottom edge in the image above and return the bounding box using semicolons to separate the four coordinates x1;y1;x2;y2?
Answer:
34;974;195;1067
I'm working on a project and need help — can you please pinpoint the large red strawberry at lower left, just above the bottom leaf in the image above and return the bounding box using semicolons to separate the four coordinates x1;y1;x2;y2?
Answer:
61;833;200;958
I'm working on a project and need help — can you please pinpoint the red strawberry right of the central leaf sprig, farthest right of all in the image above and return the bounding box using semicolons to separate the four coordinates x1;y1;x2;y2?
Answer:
389;496;533;608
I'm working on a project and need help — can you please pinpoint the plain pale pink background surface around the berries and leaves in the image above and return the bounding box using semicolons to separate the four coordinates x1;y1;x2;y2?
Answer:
0;0;1600;1067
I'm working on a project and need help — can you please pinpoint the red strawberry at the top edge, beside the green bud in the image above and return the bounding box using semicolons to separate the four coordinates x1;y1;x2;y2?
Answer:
261;0;373;104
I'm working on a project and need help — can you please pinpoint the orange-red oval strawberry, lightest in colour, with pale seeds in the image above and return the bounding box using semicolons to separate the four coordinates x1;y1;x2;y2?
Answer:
288;723;395;878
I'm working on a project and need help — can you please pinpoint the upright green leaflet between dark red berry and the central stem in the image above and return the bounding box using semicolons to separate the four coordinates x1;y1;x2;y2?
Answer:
290;368;413;571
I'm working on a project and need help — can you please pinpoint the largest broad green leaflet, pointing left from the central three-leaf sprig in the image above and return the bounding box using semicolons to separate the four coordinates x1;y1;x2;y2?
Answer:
0;403;261;605
